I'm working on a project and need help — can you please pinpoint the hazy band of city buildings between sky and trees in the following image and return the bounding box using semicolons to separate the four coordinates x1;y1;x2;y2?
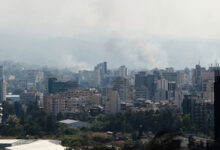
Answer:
0;62;219;128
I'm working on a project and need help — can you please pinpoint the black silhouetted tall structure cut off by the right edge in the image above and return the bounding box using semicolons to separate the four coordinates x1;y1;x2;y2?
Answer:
214;69;220;149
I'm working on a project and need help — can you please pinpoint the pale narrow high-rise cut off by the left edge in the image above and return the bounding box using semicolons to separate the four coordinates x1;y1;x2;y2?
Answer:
0;66;6;101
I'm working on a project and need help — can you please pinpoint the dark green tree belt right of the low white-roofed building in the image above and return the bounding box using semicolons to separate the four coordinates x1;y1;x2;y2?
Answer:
91;109;212;139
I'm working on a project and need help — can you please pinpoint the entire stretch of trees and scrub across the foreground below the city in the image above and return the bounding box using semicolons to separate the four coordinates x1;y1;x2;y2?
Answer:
0;102;213;150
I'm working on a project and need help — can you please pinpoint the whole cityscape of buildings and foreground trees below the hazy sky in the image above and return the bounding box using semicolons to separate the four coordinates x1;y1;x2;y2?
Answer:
0;61;220;150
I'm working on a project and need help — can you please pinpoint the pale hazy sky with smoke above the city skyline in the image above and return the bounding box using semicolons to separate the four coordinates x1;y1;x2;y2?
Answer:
0;0;220;70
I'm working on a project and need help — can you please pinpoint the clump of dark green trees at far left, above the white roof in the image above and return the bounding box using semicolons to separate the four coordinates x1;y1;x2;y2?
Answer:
0;102;59;138
